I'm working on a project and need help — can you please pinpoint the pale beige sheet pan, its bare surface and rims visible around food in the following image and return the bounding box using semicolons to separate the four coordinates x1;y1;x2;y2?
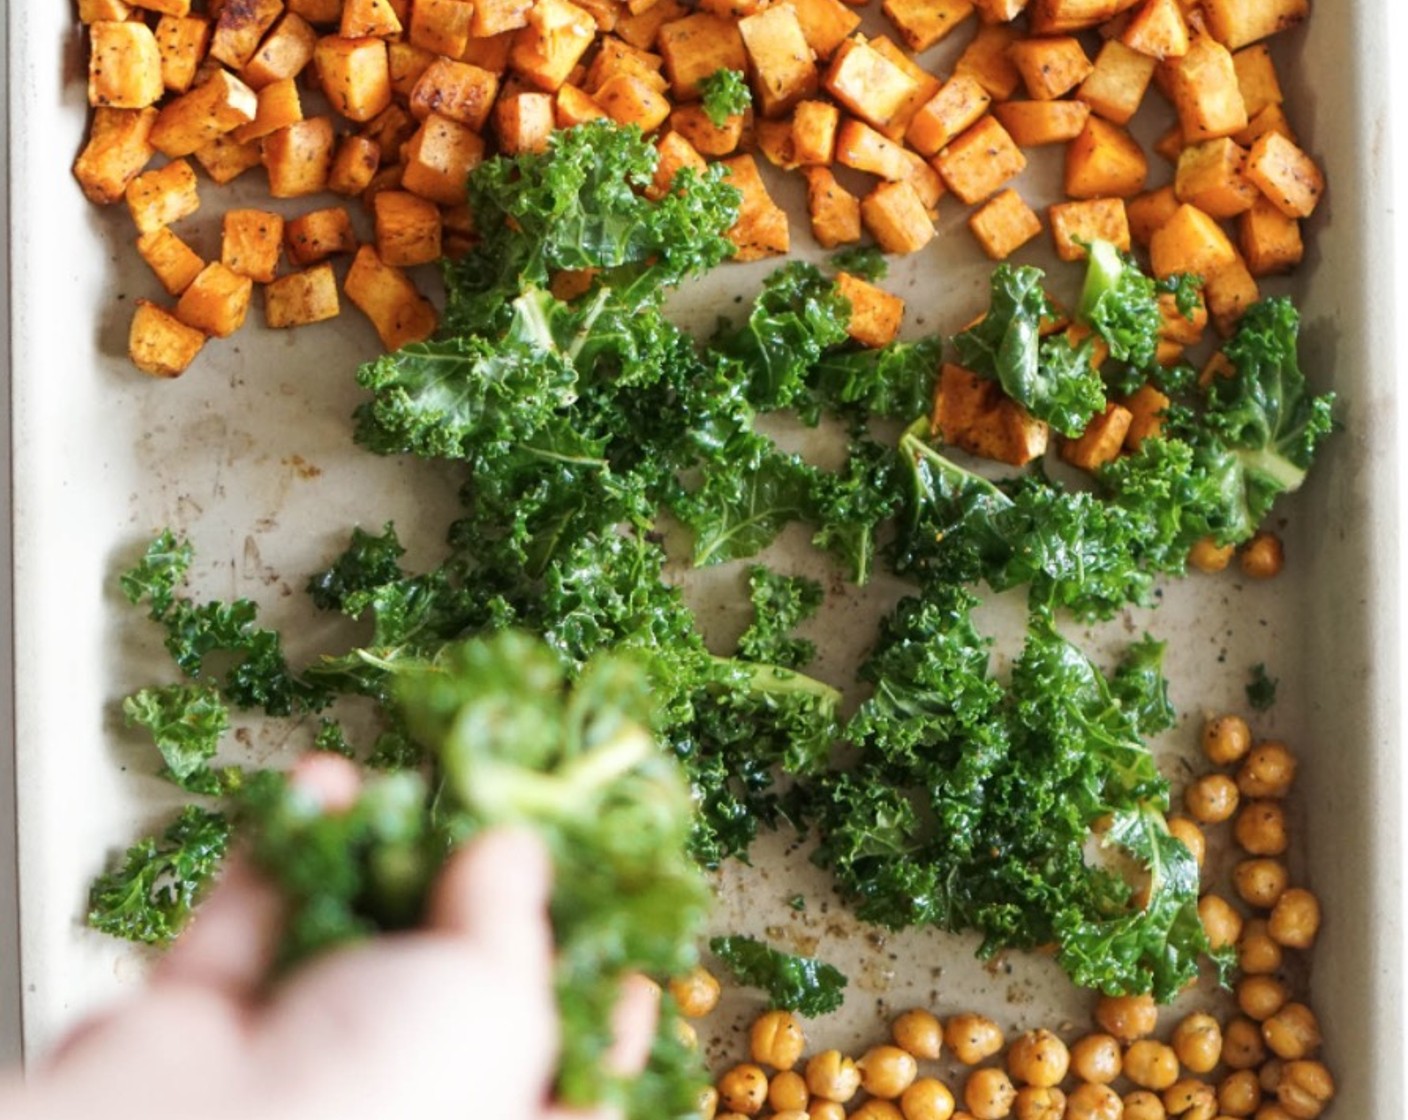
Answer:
0;3;1405;1116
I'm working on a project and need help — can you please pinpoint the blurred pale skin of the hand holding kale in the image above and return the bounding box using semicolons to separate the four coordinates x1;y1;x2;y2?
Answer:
0;757;655;1120
